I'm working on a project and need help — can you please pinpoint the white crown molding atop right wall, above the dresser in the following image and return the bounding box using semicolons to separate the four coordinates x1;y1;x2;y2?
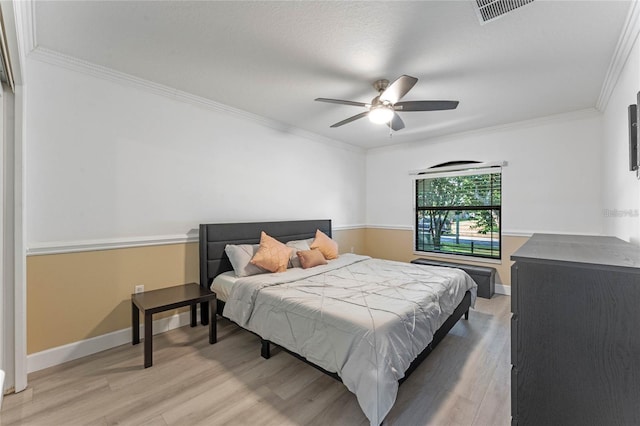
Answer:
596;0;640;111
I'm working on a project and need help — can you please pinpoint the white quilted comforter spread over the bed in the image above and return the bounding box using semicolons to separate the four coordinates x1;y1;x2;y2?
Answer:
224;254;477;425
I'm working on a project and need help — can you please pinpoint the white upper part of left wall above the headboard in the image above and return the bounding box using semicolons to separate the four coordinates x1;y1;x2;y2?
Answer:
26;59;365;248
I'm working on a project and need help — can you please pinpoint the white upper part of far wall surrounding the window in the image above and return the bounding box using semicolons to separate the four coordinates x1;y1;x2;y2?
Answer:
367;111;602;234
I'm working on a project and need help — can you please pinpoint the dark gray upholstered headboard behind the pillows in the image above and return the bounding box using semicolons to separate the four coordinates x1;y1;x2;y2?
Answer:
200;219;331;288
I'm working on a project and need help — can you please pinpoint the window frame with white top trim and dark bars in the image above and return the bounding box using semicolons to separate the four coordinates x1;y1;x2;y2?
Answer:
410;162;506;263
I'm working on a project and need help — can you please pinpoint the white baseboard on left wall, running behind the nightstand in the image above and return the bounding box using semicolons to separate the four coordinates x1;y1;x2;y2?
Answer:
27;309;200;373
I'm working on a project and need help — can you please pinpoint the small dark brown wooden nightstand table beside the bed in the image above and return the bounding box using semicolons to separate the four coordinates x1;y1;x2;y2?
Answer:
131;283;217;368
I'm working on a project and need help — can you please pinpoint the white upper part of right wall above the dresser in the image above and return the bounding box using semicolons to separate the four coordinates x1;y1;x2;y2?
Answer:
602;34;640;244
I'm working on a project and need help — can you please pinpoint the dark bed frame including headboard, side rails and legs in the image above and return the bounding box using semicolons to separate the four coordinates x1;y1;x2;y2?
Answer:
200;220;471;383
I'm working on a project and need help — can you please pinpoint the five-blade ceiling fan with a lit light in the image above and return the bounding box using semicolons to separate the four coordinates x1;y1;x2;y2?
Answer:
316;75;458;130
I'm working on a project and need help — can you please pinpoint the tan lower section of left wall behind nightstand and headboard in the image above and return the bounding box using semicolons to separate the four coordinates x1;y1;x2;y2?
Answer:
27;229;365;354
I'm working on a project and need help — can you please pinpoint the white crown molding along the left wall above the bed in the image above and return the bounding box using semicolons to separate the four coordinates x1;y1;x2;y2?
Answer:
29;46;366;153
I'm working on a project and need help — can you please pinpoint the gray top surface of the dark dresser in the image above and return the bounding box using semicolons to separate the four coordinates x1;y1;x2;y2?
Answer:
511;234;640;273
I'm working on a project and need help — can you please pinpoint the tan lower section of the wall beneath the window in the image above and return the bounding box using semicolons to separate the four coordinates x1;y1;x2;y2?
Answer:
363;228;529;285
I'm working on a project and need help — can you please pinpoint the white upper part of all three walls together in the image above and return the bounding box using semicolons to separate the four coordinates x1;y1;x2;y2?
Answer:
26;22;640;248
